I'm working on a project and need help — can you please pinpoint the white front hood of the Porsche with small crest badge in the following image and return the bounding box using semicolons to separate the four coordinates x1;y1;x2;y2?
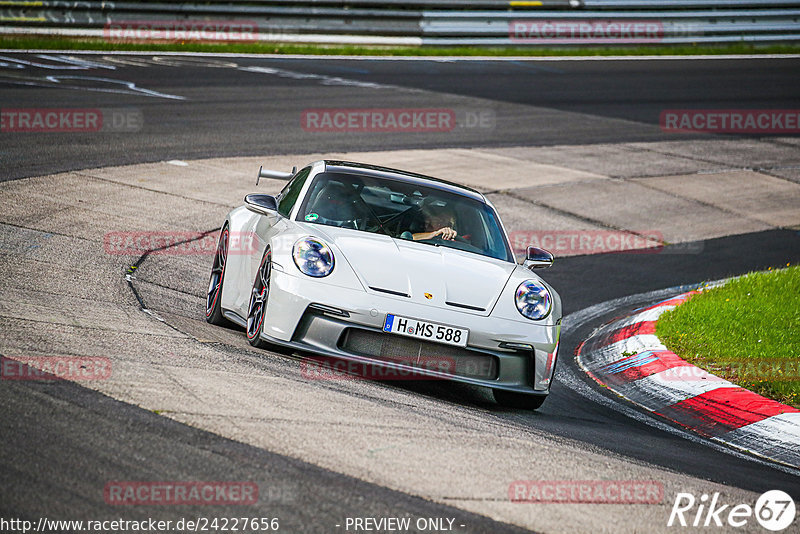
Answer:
314;225;516;315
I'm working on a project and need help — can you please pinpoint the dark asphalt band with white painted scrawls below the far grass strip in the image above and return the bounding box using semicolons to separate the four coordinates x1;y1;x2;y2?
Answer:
0;54;800;179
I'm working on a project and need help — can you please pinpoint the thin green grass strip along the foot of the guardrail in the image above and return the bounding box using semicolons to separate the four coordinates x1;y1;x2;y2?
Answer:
0;35;800;57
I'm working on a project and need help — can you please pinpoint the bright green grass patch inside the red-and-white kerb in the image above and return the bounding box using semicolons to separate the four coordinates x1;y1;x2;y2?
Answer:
656;264;800;407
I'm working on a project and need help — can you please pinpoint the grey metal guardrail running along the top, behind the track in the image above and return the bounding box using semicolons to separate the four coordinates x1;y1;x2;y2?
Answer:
0;0;800;46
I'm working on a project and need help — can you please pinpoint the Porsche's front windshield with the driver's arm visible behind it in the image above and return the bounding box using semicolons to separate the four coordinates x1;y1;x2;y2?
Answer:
297;173;514;262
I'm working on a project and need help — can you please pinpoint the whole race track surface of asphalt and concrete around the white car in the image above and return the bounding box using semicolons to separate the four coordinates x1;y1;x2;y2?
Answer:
0;52;800;532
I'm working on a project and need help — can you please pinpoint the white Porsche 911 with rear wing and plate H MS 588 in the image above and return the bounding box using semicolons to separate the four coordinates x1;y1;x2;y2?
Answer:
206;160;561;409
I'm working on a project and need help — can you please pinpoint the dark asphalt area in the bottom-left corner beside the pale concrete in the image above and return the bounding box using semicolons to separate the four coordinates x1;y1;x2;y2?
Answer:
0;368;529;533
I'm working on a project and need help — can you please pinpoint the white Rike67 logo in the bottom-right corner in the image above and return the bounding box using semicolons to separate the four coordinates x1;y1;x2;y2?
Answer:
667;490;796;532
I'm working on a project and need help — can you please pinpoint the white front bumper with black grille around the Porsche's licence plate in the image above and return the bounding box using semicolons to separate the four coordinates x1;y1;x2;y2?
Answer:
262;266;561;395
